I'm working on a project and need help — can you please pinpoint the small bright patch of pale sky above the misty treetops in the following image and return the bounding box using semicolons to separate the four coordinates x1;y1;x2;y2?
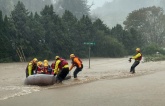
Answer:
88;0;113;9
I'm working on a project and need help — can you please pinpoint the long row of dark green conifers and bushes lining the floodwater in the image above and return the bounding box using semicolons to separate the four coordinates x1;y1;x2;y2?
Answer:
0;1;152;62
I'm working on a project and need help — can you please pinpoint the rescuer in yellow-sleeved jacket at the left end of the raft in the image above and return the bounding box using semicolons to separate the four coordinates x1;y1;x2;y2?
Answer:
26;58;38;77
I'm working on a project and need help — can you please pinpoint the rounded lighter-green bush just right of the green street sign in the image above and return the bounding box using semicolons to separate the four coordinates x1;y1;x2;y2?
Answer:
92;31;126;57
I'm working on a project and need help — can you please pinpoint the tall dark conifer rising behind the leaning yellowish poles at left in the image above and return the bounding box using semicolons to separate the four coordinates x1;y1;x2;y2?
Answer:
10;1;31;61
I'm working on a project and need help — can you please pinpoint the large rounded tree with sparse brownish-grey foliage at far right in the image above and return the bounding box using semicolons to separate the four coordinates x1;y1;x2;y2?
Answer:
124;6;165;46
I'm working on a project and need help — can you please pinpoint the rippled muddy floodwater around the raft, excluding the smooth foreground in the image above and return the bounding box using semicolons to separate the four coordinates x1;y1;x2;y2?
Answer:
0;58;165;101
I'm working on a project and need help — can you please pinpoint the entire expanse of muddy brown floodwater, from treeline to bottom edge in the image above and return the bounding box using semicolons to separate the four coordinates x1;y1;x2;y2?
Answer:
0;58;165;106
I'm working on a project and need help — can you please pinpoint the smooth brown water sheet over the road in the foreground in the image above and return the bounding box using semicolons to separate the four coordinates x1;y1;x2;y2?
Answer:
0;71;165;106
